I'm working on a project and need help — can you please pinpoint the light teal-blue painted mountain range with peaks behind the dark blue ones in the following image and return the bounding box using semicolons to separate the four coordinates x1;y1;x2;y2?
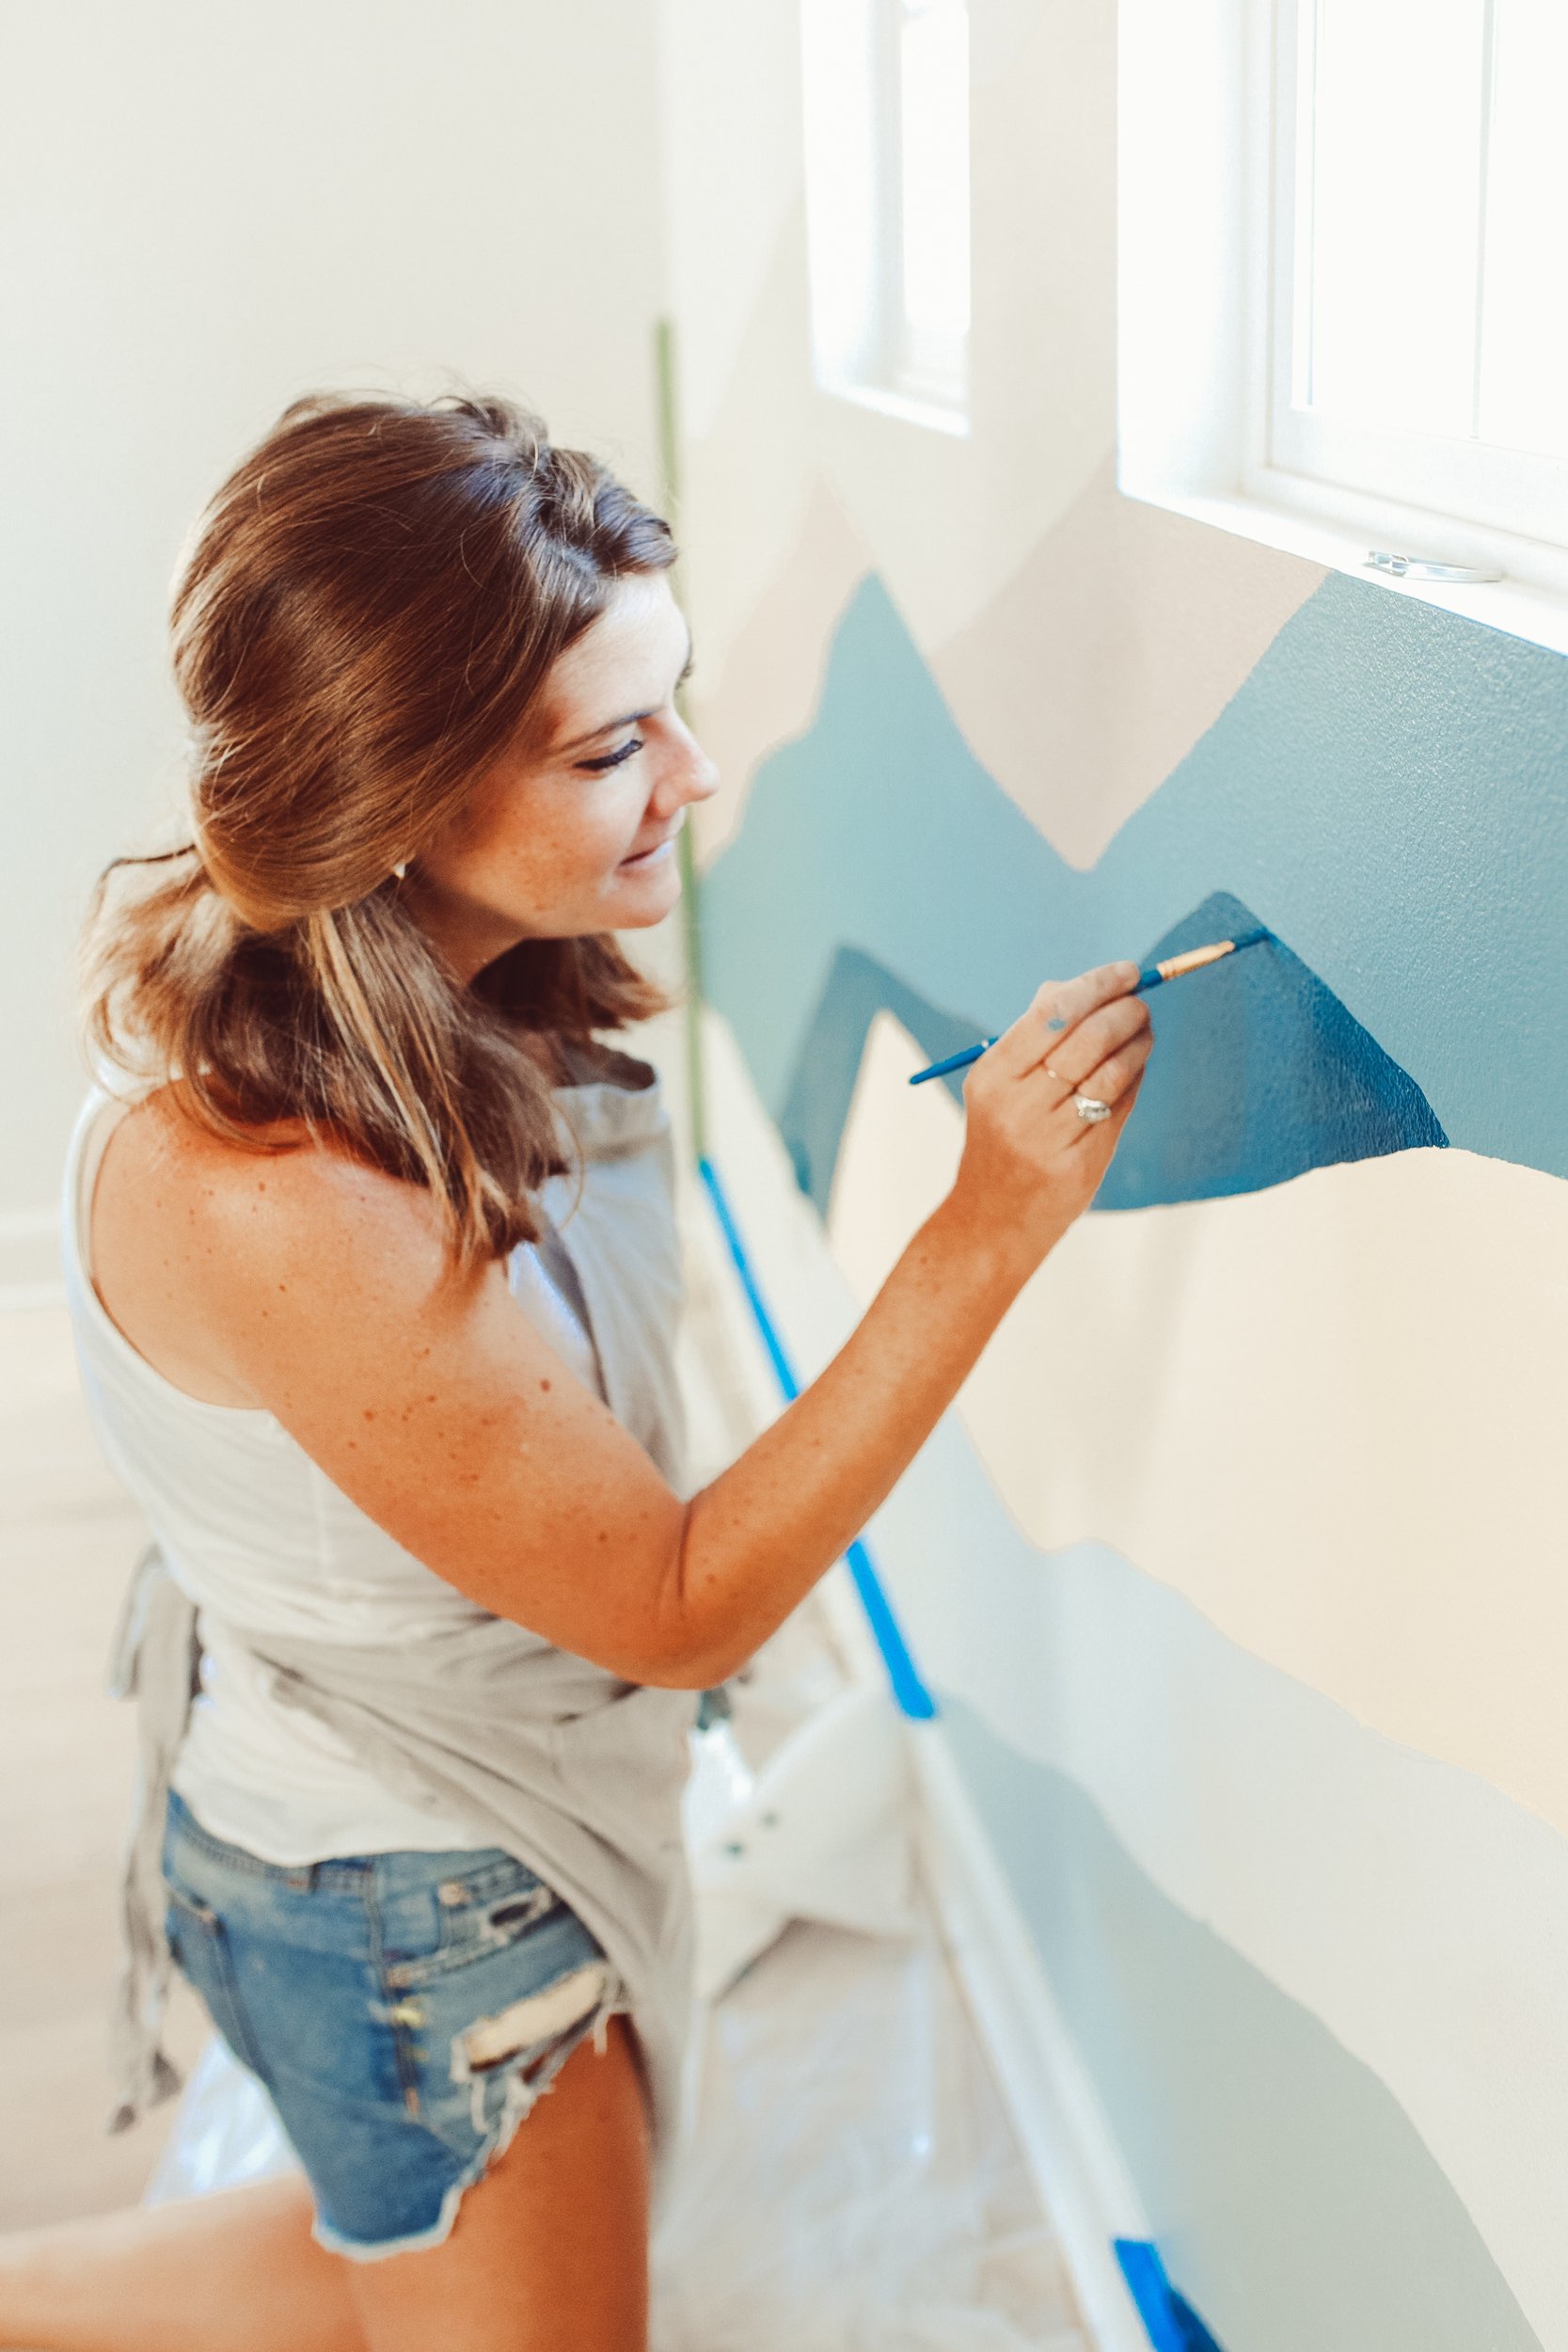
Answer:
703;574;1568;1176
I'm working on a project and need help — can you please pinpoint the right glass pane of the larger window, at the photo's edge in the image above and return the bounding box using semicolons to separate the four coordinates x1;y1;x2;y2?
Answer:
1481;0;1568;456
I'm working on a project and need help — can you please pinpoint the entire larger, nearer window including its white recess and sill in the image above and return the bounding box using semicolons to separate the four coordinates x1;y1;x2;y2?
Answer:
1121;0;1568;643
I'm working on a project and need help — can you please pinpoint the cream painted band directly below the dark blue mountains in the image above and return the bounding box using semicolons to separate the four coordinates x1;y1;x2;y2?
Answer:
830;1014;1568;1830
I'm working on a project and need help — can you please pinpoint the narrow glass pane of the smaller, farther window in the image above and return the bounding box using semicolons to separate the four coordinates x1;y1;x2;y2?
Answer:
898;0;969;337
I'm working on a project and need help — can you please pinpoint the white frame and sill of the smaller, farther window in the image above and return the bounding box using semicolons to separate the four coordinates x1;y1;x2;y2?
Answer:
801;0;969;437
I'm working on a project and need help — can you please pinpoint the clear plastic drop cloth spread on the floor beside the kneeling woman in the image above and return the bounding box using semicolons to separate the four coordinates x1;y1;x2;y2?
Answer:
148;1924;1091;2352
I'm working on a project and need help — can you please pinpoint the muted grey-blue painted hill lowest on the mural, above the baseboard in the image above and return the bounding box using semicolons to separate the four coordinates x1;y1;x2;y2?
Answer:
941;1692;1540;2352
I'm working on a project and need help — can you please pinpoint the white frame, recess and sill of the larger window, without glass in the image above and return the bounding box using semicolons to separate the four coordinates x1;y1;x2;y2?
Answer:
1117;0;1568;652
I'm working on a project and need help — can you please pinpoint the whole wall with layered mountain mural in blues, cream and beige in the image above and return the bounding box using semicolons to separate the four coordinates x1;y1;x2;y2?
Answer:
673;0;1568;2352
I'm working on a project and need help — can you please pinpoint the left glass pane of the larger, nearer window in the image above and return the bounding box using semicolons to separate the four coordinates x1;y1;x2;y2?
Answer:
1303;0;1495;436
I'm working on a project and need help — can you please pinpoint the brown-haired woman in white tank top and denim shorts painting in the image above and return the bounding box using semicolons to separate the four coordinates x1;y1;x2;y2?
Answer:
0;398;1149;2352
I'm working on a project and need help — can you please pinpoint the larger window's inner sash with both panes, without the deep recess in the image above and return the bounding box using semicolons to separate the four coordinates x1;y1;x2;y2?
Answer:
1267;0;1568;544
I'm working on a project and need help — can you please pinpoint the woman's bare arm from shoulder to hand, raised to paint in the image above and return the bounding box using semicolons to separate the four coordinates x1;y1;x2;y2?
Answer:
94;964;1148;1689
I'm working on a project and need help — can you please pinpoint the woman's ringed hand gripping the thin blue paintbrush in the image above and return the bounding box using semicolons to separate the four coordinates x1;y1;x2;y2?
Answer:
950;962;1154;1265
